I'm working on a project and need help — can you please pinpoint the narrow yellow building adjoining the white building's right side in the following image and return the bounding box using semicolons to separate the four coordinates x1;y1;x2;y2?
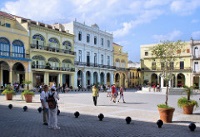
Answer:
113;43;128;88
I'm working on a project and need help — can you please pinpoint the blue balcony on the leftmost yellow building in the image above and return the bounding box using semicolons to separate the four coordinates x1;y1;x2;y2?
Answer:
0;50;30;61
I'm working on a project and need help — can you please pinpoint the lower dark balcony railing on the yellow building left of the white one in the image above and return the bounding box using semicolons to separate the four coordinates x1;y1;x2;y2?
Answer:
32;65;75;72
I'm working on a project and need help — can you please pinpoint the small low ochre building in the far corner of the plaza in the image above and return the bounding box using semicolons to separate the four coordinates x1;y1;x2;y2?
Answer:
128;61;141;87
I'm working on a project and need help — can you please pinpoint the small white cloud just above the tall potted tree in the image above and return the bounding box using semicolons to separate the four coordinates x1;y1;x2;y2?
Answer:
153;30;182;42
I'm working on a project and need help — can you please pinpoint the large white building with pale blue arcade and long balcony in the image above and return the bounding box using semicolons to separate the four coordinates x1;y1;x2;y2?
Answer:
63;21;115;88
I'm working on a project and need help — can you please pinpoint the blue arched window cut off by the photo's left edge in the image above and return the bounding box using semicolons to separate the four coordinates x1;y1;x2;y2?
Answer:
0;37;10;56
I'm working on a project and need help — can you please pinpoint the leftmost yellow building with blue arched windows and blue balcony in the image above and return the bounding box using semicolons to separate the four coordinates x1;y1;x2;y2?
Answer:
0;11;31;86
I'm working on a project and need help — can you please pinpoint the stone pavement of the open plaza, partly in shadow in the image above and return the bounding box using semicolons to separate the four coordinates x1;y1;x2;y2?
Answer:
0;92;200;137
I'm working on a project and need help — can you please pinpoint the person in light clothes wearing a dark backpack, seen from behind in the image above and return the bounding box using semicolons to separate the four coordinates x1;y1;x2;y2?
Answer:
47;88;60;129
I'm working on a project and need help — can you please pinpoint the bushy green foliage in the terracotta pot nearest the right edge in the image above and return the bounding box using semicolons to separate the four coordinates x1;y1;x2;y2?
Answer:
177;97;199;108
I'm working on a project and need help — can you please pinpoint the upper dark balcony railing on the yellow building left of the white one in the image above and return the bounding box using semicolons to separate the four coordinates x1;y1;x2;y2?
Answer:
30;44;76;55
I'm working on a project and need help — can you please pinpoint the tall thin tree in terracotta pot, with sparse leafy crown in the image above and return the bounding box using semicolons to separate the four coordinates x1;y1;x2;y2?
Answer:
150;41;184;123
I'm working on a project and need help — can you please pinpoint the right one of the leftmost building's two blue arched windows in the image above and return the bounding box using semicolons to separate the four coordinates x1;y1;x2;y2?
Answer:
12;40;25;58
